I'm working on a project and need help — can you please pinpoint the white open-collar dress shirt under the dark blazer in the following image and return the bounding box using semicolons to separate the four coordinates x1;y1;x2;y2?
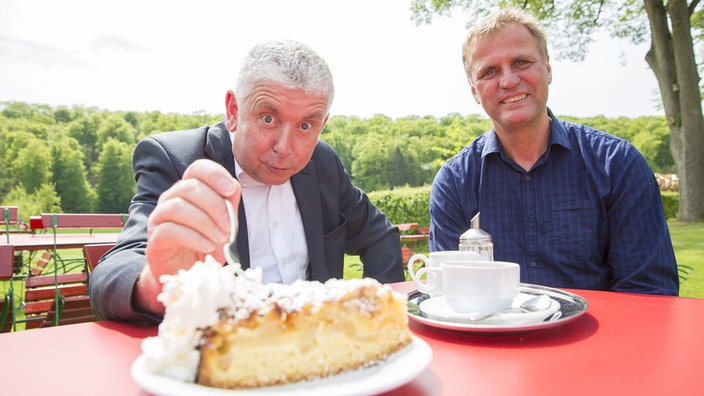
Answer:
235;156;308;284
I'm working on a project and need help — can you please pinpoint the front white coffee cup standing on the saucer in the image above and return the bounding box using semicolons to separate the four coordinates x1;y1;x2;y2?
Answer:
415;260;521;315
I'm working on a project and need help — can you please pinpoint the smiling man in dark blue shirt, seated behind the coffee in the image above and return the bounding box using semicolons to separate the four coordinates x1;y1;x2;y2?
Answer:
430;10;679;295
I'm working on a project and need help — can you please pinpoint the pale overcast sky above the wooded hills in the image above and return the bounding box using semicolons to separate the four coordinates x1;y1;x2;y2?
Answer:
0;0;662;118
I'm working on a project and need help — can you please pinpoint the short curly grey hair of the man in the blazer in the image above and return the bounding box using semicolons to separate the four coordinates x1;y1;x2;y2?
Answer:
235;40;335;109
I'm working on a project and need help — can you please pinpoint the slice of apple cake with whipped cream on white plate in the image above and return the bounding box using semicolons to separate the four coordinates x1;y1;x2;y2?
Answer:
143;254;411;389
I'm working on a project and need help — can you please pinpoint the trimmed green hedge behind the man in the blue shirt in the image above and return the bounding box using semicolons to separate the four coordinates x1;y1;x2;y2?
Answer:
367;186;679;227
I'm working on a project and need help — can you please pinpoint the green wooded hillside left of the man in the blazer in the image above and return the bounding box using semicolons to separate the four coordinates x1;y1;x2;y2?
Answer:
0;102;222;219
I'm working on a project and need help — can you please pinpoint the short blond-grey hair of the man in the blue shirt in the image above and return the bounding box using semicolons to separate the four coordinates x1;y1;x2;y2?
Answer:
462;8;548;81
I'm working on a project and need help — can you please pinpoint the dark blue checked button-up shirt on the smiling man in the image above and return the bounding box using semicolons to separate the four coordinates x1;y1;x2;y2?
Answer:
429;111;679;295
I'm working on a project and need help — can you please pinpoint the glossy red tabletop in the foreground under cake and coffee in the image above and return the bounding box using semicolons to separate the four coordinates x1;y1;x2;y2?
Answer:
0;282;704;396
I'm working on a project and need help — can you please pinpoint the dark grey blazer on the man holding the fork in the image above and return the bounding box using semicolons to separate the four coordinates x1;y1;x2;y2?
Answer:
89;123;404;322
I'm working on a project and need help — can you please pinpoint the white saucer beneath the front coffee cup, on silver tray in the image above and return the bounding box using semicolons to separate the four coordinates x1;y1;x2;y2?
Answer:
418;293;560;325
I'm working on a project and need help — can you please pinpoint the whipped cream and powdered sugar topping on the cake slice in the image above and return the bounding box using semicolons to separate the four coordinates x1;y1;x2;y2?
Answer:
142;256;398;382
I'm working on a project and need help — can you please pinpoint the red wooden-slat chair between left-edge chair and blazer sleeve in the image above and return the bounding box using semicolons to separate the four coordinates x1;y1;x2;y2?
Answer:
23;272;88;329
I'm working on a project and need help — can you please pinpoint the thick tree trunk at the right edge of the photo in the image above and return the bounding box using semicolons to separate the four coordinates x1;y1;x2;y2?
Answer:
644;0;704;222
